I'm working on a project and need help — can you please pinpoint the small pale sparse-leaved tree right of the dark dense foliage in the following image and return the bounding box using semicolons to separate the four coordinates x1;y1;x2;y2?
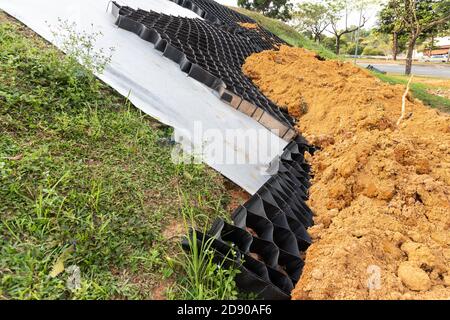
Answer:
292;2;330;42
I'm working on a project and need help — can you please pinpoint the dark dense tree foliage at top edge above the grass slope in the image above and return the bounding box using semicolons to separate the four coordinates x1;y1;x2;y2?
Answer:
238;0;292;21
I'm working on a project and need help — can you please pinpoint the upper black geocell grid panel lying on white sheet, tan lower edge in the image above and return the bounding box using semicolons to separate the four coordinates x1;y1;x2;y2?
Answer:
113;2;295;141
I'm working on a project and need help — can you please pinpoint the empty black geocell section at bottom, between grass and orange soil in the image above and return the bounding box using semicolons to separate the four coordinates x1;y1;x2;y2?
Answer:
183;137;315;300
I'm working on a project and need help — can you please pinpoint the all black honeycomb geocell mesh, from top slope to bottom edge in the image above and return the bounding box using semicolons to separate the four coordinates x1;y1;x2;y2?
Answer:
113;0;315;299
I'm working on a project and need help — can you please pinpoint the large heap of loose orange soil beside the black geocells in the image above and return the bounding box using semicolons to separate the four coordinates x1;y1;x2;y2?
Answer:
243;46;450;299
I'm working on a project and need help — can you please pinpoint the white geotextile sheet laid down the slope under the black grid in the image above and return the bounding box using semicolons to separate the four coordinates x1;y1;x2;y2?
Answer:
0;0;287;194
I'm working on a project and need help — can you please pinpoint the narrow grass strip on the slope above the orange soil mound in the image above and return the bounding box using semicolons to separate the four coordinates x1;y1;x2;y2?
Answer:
232;7;337;59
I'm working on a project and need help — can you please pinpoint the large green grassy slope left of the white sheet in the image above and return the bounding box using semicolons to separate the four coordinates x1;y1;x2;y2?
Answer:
0;12;243;299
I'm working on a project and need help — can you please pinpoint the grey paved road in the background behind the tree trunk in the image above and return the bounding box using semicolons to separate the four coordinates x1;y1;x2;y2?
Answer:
358;62;450;79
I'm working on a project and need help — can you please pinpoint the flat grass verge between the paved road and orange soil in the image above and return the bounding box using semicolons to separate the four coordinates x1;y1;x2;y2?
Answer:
373;72;450;112
